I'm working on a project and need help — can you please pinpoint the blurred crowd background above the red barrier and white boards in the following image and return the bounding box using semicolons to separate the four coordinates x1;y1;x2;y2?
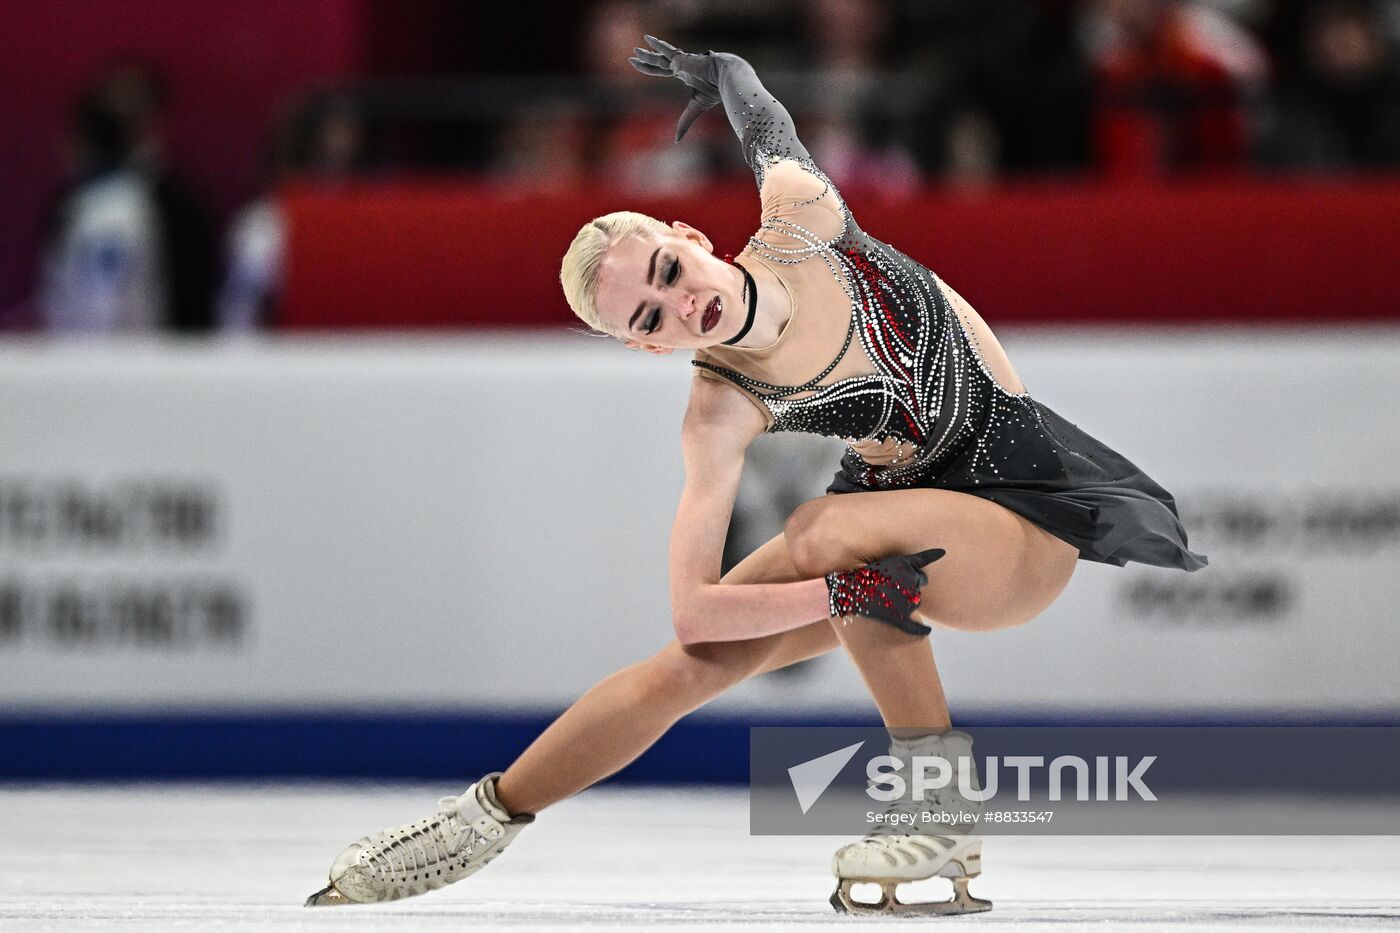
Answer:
0;0;1400;332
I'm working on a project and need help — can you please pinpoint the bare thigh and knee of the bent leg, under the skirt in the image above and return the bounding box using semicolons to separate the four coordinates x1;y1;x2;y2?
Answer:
787;489;1079;630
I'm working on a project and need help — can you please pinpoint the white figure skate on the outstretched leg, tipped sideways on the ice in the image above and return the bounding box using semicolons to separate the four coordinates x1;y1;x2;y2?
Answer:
307;772;535;906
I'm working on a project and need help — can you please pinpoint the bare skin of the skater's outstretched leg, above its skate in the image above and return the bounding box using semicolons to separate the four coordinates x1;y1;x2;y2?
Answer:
496;535;837;813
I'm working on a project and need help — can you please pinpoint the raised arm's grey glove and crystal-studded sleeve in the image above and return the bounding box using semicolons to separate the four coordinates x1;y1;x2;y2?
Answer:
629;35;812;186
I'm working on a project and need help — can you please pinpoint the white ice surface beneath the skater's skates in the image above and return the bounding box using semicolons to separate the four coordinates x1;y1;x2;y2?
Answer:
0;785;1400;933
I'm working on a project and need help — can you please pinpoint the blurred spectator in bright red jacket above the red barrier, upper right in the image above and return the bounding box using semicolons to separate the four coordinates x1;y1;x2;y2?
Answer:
1085;0;1267;178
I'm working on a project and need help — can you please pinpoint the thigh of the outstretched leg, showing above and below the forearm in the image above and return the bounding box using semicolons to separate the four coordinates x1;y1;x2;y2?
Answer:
668;535;840;677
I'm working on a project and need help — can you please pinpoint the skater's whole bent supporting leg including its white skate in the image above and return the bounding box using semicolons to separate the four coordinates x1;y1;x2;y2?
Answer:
785;489;1078;915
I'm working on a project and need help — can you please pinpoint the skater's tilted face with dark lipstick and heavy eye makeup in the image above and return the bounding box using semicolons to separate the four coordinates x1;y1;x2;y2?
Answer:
596;220;748;353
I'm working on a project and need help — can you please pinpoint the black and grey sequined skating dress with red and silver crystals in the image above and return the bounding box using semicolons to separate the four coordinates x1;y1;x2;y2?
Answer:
693;53;1207;570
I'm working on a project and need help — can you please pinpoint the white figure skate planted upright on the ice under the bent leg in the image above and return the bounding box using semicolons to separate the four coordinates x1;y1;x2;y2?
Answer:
832;731;991;916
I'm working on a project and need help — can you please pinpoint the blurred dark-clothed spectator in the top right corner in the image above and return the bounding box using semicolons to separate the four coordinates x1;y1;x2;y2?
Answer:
1261;1;1400;168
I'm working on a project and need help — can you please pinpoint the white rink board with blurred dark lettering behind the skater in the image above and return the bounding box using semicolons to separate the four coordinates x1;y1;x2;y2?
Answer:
0;329;1400;714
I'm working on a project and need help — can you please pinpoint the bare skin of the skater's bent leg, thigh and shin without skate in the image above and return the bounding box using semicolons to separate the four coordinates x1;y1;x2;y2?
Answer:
784;489;1078;733
